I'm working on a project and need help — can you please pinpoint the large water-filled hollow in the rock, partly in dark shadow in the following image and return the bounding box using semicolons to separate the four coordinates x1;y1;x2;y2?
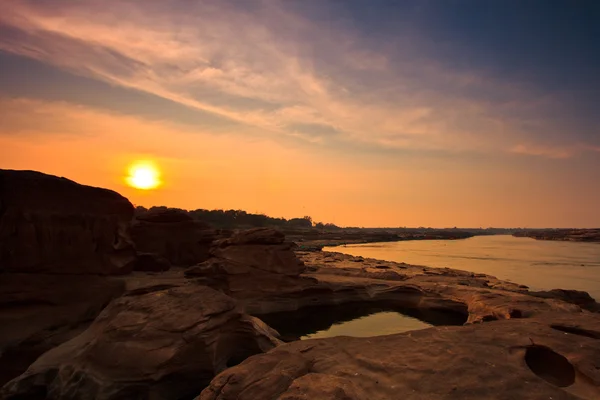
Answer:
257;302;468;342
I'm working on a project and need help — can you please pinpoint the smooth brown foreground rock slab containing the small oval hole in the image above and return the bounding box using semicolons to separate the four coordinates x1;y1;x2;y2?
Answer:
197;314;600;400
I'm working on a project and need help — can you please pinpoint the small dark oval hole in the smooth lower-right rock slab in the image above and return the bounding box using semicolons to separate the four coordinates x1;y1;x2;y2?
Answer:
525;345;575;387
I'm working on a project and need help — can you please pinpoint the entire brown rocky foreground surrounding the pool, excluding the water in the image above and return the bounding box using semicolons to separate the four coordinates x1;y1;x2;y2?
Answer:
0;171;600;400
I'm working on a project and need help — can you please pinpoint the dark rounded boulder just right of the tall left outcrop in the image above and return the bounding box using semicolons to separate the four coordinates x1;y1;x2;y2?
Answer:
131;209;221;267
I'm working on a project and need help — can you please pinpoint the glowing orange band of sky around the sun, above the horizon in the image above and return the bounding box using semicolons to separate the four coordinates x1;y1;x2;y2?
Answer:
0;100;597;227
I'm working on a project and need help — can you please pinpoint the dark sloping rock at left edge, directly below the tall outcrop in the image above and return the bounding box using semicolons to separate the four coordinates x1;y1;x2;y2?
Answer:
0;273;125;386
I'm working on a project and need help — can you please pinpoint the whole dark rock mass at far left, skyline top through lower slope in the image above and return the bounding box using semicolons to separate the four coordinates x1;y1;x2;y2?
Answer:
0;170;135;384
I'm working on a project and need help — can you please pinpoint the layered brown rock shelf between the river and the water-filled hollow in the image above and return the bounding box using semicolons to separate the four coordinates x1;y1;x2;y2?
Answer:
229;252;582;324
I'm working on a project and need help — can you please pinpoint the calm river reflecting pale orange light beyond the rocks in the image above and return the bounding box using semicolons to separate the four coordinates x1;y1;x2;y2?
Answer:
323;235;600;301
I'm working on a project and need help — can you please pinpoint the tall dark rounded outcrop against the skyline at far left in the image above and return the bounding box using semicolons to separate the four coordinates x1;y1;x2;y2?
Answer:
0;170;134;274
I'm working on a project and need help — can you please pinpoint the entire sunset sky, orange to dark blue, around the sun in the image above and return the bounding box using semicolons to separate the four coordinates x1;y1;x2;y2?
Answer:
0;0;600;227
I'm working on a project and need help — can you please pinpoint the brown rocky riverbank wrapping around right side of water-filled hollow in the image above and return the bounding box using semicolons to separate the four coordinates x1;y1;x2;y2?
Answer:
196;252;600;400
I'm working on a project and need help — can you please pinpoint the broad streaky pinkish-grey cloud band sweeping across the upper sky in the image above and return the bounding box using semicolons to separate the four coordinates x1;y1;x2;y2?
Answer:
0;0;596;158
